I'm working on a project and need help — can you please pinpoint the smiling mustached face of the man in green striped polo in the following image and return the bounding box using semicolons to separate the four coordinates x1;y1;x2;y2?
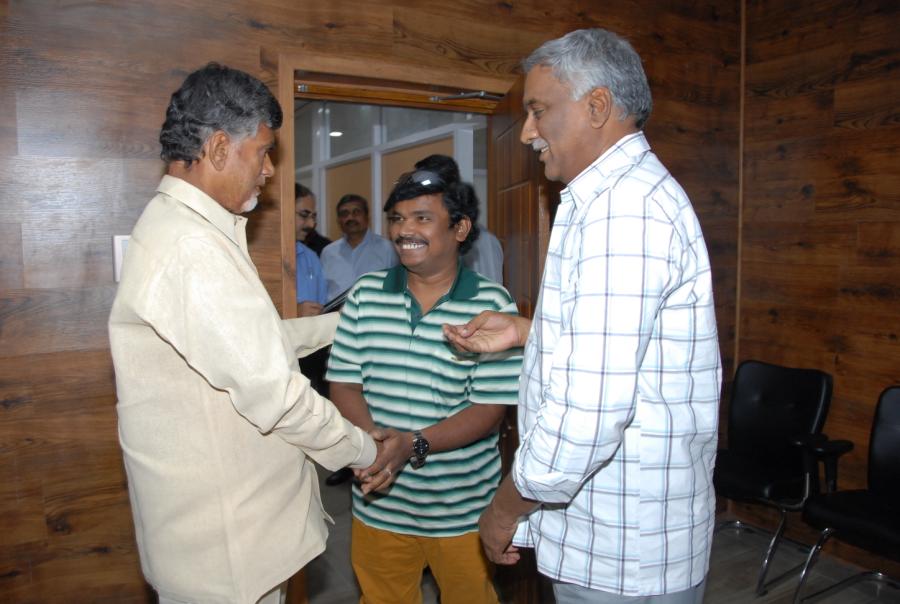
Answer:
388;193;472;277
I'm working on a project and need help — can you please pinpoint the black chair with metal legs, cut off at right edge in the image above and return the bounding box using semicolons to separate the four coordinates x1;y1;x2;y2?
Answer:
794;386;900;604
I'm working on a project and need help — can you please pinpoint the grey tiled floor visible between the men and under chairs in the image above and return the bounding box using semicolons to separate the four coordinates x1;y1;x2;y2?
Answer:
307;468;900;604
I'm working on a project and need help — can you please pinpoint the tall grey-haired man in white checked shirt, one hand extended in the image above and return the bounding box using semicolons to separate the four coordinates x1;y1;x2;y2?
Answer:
445;29;721;604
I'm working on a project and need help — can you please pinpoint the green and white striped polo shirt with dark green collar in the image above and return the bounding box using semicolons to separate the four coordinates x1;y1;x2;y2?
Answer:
327;265;522;537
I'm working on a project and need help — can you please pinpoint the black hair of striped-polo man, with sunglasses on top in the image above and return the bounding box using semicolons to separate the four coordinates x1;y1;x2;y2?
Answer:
384;170;480;254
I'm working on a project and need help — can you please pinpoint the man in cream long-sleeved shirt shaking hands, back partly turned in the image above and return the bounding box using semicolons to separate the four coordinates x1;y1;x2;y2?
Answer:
109;64;376;604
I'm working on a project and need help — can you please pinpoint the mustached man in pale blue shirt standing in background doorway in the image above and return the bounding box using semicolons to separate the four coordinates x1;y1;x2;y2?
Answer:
321;193;397;300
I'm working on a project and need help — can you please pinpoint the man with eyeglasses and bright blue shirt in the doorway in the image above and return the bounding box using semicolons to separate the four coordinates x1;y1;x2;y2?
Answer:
294;183;328;317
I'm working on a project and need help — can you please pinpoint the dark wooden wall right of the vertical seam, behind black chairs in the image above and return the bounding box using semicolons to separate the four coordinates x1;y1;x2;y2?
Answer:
732;0;900;568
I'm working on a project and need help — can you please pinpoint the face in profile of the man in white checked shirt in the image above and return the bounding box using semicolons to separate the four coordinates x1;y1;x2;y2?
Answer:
520;65;599;184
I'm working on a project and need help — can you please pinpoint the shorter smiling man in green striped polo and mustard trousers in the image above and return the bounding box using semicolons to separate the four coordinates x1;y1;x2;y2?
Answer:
327;170;522;604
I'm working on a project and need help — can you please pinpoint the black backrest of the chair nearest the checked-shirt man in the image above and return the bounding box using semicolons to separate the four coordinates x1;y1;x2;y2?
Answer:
728;361;832;473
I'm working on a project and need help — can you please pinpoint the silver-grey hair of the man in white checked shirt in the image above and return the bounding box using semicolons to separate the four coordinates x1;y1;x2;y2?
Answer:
522;29;653;128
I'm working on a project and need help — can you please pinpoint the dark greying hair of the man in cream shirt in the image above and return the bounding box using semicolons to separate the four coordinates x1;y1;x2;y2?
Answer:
159;63;282;164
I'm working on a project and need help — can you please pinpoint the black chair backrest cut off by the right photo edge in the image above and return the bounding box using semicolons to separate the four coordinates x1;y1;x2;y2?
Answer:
869;386;900;502
